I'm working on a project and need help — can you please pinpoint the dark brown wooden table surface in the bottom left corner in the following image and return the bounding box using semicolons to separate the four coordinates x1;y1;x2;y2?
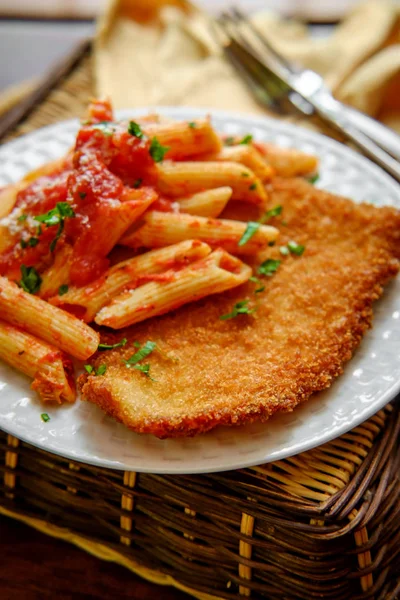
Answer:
0;517;190;600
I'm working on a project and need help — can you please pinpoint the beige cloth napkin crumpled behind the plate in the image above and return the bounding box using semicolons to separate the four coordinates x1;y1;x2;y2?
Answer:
95;0;400;131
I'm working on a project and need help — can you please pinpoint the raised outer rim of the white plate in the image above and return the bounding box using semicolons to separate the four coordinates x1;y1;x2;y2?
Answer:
0;106;400;475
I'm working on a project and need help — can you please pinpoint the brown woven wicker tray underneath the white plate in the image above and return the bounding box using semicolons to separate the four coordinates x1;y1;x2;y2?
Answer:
0;44;400;600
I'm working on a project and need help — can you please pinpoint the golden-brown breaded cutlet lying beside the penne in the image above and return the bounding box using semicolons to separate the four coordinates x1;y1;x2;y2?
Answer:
79;178;400;438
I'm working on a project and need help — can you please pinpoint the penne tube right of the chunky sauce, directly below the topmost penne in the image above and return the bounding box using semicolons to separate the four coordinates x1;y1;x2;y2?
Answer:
157;161;267;206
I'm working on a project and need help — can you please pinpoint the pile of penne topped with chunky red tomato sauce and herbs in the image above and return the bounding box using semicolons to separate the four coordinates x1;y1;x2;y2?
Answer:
0;101;316;402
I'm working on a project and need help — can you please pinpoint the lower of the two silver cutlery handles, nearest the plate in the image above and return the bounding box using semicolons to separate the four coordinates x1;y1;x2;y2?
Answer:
313;102;400;183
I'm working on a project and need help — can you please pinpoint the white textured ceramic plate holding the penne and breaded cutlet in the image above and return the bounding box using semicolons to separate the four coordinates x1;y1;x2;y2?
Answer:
0;108;400;473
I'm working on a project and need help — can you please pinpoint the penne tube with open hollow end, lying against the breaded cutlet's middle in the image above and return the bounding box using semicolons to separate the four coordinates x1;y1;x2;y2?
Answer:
95;249;252;329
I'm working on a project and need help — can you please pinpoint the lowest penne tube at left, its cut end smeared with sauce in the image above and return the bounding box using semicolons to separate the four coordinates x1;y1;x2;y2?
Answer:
0;321;76;403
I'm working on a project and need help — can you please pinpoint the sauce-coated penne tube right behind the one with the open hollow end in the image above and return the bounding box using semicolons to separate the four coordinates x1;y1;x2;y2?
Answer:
49;240;211;323
